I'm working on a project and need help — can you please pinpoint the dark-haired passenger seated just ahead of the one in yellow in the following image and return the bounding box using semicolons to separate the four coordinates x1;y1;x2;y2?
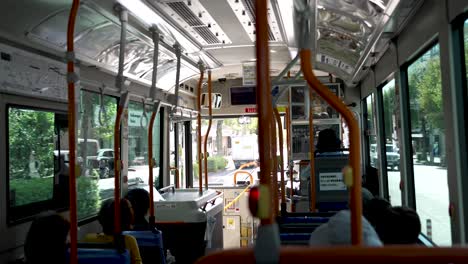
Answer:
126;188;151;230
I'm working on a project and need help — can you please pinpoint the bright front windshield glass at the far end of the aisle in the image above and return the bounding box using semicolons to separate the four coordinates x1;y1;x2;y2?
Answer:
192;116;262;186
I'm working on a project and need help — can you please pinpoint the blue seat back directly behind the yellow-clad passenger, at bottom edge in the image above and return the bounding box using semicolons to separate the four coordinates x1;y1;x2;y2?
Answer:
68;248;130;264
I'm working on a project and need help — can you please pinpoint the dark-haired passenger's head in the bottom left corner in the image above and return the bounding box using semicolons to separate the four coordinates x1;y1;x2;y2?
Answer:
24;213;70;264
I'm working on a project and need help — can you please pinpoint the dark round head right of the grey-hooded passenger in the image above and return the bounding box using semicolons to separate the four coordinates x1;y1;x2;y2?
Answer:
376;206;421;245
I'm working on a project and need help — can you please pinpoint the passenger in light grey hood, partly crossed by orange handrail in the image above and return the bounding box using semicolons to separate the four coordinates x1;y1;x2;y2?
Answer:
309;210;382;247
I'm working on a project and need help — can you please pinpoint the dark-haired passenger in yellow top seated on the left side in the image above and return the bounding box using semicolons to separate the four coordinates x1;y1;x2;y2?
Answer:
83;199;142;264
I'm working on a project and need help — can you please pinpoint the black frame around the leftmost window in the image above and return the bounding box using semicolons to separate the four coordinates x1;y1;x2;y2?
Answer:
5;102;68;226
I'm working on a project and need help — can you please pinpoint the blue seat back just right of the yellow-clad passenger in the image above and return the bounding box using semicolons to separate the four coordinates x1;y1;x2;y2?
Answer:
123;229;166;264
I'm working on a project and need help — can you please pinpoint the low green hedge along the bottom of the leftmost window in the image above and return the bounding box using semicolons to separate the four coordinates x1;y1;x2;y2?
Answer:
10;177;54;206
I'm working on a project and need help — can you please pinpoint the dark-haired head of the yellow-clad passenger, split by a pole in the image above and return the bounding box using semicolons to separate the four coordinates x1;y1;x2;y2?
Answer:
98;199;134;235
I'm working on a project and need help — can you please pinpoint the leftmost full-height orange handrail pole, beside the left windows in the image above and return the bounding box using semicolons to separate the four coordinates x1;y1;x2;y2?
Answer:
67;0;80;264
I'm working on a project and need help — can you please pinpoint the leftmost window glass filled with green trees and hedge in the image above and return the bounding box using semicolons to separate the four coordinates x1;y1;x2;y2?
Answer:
8;107;56;207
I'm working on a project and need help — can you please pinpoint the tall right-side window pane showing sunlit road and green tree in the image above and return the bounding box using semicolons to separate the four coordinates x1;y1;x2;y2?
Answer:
408;44;451;245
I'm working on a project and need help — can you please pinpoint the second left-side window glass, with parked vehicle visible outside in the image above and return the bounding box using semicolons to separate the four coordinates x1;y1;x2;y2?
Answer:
77;90;117;219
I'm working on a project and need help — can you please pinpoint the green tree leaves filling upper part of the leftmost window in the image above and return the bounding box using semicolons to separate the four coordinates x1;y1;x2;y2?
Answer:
8;107;55;179
